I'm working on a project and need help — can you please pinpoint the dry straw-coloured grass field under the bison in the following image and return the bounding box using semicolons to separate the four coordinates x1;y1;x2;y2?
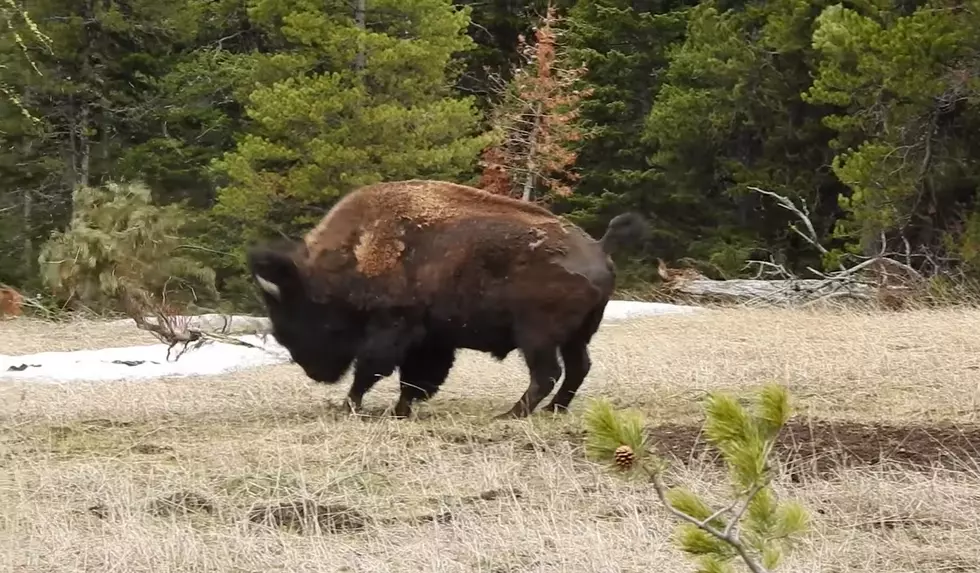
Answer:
0;310;980;573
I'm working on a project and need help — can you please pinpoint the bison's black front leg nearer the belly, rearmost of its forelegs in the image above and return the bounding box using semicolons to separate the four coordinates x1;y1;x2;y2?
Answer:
394;338;456;418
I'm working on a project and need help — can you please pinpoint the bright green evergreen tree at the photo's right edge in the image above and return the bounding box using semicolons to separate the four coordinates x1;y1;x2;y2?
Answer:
806;1;980;270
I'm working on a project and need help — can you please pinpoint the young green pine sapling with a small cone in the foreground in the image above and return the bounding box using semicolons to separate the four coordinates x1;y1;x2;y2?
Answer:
585;385;808;573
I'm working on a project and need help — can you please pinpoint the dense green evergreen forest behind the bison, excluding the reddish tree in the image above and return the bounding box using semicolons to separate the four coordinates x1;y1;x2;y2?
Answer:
0;0;980;303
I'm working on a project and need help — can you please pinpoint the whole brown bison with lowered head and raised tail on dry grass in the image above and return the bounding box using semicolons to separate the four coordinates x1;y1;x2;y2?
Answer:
247;180;647;418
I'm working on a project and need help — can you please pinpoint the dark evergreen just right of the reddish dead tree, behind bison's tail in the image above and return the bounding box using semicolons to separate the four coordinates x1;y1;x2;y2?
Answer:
554;0;691;246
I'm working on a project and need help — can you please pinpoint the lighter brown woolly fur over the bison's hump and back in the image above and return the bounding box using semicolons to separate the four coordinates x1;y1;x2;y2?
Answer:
304;180;593;302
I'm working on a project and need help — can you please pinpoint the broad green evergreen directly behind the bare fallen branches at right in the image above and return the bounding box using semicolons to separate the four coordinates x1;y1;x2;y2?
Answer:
646;0;843;275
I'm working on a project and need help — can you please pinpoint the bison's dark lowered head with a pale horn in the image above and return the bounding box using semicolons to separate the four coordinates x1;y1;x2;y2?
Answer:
248;242;363;383
